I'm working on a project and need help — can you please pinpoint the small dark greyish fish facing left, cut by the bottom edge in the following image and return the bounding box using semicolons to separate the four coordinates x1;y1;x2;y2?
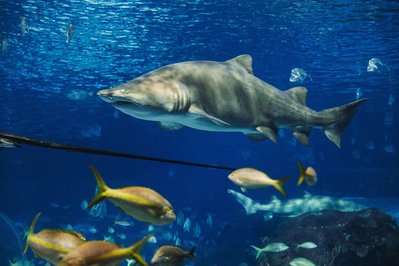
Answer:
151;245;197;266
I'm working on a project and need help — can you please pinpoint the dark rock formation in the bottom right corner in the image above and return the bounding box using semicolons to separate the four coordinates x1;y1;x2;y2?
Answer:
256;208;399;266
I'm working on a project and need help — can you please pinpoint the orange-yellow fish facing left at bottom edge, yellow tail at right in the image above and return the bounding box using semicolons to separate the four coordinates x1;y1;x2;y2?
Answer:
57;234;154;266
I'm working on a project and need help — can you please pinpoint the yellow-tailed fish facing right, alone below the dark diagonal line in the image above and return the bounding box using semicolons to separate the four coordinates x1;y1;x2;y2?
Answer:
87;164;176;225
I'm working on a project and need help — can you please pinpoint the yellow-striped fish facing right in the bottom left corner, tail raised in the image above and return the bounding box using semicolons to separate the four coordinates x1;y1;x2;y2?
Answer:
22;213;86;265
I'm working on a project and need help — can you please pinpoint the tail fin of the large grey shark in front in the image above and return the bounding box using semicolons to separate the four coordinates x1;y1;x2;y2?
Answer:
319;98;369;148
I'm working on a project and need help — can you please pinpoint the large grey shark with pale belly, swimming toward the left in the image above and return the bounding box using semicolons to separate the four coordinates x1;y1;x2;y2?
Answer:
97;54;368;147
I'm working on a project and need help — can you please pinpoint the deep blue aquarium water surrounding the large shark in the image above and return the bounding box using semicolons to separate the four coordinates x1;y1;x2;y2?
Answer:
0;0;399;266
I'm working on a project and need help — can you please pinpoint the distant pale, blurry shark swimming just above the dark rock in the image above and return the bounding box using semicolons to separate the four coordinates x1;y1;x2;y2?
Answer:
227;189;368;217
